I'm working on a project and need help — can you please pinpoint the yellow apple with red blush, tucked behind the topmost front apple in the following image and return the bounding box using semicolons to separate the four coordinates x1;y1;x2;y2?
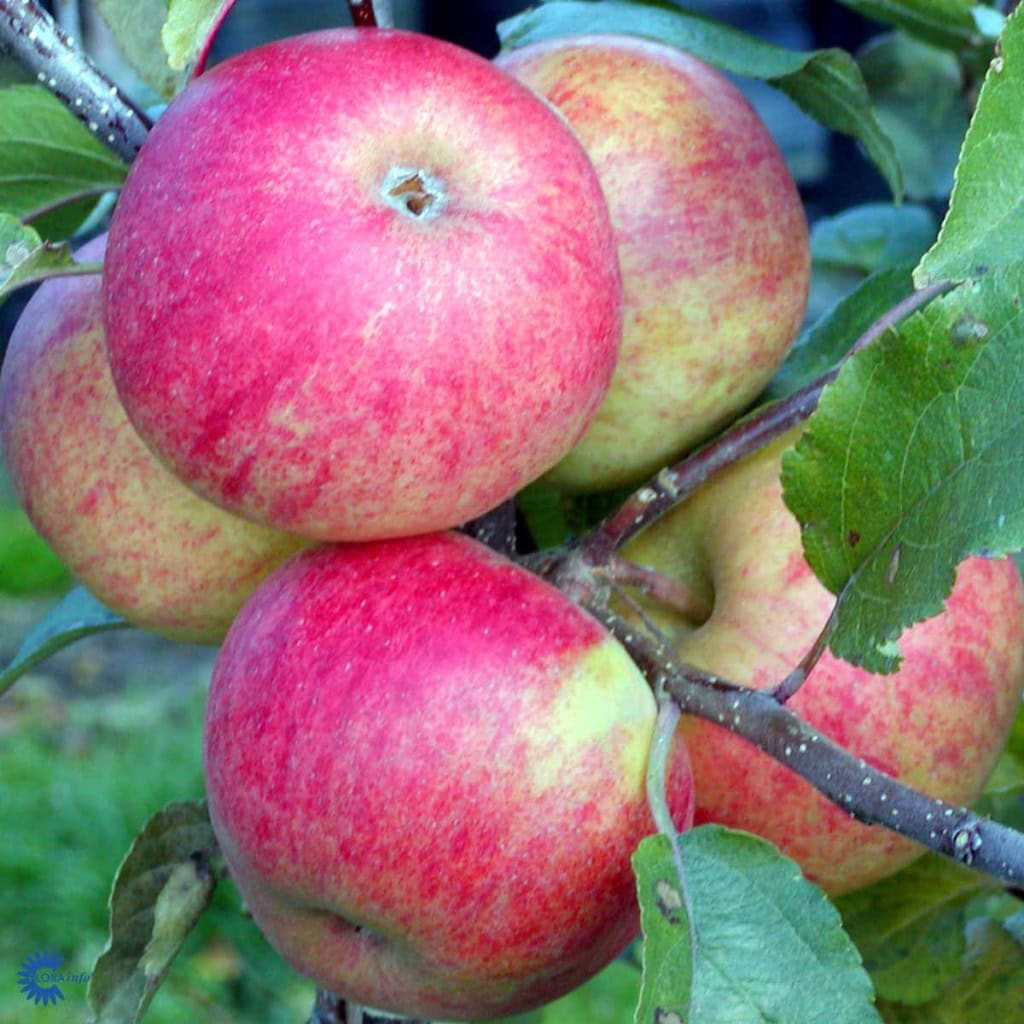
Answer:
496;35;810;490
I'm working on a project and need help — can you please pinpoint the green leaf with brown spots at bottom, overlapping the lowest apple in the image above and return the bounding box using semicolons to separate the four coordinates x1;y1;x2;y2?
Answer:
633;825;879;1024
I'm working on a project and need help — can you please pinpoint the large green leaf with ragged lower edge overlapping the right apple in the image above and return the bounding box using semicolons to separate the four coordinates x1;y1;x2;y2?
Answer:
782;264;1024;672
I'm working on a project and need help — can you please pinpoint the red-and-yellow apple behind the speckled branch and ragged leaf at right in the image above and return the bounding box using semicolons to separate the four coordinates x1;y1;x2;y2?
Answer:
624;436;1024;895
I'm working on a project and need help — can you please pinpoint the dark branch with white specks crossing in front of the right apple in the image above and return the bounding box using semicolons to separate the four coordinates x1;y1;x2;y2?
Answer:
588;600;1024;888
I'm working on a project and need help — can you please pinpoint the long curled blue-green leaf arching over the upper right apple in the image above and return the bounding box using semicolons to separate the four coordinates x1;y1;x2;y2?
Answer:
498;0;903;197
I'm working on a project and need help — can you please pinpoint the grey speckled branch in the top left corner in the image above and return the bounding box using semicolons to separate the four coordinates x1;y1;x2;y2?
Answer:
0;0;153;163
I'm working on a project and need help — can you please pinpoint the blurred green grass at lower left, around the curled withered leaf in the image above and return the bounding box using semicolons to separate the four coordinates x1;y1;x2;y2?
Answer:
0;675;312;1024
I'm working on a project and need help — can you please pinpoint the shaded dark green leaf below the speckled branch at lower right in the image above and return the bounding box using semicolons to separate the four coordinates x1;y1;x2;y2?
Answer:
837;853;996;1002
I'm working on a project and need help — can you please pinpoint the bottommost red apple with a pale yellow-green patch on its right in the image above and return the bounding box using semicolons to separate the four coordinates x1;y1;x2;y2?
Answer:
205;534;692;1020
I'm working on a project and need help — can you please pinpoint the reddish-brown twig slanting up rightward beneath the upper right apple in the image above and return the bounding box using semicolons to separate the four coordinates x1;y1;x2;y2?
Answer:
580;281;952;564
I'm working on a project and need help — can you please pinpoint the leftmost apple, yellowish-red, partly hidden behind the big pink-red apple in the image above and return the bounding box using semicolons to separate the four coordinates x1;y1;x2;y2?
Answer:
0;238;307;642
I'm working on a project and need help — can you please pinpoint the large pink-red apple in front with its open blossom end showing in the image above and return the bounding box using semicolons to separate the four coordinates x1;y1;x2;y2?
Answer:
104;29;622;541
